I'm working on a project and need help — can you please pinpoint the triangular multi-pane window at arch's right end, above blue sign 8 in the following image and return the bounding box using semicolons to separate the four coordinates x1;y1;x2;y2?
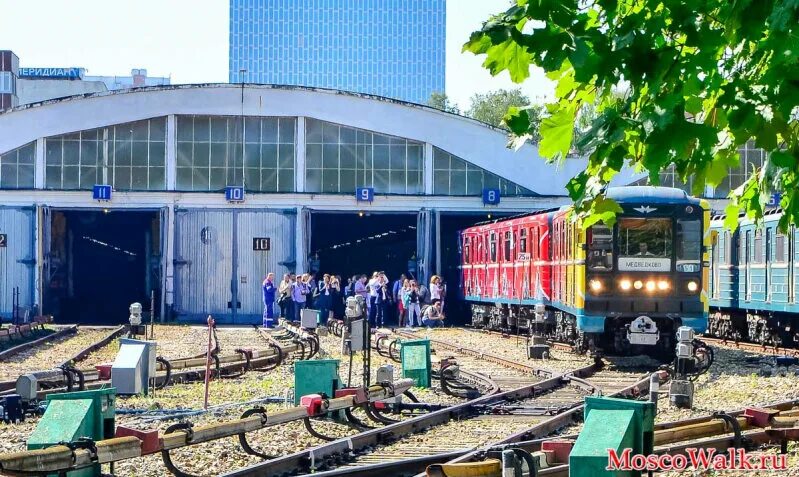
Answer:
433;147;536;196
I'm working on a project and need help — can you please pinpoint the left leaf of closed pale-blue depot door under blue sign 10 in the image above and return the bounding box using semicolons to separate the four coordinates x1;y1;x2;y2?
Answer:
175;209;233;321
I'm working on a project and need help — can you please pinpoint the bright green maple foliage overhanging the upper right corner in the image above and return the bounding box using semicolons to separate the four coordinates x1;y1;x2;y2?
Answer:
464;0;799;231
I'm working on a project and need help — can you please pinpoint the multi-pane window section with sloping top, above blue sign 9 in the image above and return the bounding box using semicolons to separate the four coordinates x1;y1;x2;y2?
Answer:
305;118;424;195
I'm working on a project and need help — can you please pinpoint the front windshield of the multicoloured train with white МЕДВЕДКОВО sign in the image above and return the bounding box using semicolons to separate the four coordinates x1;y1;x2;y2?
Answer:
619;218;673;271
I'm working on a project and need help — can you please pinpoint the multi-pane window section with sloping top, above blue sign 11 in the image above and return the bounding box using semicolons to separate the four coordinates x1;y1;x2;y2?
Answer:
45;117;166;190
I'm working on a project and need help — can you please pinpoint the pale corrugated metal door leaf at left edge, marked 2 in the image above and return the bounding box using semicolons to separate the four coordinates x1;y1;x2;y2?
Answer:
0;207;35;319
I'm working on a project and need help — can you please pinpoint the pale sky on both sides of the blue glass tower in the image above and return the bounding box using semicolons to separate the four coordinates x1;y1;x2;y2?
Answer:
0;0;553;110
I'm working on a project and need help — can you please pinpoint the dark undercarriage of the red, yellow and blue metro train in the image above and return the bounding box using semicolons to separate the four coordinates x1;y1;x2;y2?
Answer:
472;304;679;359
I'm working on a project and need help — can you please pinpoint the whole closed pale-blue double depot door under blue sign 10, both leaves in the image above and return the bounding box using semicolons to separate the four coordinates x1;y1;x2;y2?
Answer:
175;209;296;323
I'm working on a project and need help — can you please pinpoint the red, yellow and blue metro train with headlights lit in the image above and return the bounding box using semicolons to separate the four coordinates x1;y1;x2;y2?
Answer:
460;186;710;355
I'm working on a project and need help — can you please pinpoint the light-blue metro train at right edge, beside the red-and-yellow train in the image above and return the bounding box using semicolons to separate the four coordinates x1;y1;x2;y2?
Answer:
708;209;799;347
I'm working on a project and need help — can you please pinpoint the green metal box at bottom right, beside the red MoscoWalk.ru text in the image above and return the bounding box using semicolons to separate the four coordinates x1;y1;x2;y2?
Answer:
569;396;655;477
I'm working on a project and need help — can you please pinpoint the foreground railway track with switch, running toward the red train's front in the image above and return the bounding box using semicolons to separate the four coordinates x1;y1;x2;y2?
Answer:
220;332;649;477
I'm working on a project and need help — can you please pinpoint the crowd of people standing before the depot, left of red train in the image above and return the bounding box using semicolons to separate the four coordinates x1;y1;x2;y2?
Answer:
262;272;447;328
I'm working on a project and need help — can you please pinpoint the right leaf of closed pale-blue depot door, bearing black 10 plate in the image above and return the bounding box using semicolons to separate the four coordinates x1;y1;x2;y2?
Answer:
236;211;297;323
